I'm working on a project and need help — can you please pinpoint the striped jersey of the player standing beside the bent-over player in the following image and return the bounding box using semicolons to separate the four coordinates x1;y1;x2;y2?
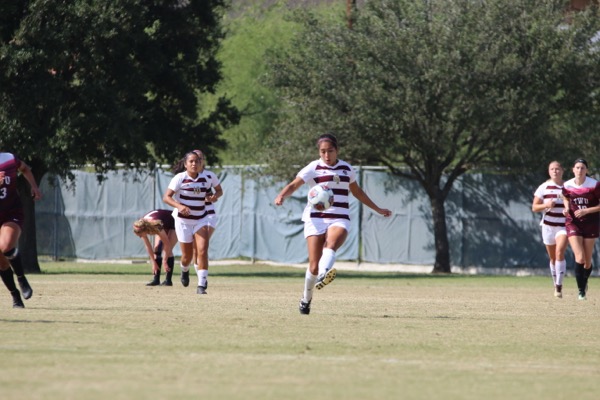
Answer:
169;170;221;224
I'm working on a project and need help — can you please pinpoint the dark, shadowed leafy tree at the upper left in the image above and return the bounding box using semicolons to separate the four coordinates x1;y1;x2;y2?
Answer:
0;0;238;271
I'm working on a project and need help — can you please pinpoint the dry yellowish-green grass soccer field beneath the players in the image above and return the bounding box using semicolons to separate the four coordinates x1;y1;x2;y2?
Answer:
0;263;600;400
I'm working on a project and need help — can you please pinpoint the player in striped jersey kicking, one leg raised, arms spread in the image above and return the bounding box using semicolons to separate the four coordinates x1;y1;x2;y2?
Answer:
275;134;392;314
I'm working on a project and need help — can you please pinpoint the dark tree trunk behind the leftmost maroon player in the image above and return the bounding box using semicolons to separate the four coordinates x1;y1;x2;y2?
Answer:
17;176;42;274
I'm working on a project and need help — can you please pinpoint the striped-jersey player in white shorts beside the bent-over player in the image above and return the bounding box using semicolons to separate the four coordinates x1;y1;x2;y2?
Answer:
163;150;223;294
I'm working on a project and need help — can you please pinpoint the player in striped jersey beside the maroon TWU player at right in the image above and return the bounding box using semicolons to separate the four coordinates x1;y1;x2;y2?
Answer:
531;161;568;298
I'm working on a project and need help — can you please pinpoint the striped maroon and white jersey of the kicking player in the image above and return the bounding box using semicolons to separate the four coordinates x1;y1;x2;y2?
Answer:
297;159;356;222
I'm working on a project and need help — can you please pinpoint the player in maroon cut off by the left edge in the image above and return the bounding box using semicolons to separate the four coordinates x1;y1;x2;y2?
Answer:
0;152;42;308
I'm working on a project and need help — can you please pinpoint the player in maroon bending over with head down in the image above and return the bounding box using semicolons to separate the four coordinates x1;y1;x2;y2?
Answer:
133;210;177;286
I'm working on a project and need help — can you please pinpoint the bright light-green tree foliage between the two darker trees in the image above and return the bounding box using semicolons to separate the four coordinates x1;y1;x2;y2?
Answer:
215;2;294;164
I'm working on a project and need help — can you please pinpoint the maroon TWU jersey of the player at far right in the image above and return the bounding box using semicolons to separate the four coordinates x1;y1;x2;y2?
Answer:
562;176;600;223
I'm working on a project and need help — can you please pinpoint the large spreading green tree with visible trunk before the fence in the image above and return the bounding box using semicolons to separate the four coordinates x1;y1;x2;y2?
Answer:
266;0;600;273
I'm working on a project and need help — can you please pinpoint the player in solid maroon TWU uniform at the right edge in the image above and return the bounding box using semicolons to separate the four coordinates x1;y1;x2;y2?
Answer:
562;158;600;300
